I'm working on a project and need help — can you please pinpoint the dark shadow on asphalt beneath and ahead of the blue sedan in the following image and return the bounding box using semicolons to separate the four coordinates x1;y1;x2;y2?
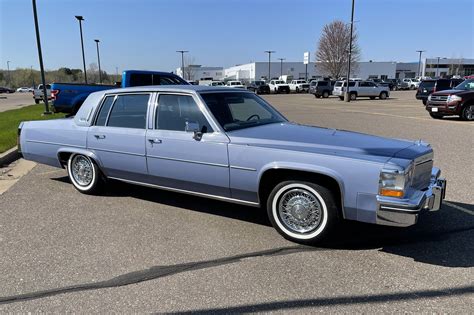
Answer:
53;177;474;268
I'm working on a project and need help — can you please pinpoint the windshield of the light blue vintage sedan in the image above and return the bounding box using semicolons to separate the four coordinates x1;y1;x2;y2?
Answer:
201;92;287;131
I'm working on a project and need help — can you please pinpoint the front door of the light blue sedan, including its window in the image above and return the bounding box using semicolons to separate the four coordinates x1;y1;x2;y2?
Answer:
146;94;230;197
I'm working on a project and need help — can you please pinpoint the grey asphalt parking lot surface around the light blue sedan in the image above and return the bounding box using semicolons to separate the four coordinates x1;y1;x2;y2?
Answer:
0;91;474;313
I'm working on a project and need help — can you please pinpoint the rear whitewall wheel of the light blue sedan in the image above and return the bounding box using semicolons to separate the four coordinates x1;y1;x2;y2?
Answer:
67;154;105;195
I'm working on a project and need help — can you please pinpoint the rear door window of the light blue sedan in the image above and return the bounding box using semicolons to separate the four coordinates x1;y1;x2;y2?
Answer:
107;94;150;129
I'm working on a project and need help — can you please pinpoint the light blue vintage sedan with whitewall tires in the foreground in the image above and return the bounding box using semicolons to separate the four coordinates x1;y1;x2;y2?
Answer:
18;86;446;243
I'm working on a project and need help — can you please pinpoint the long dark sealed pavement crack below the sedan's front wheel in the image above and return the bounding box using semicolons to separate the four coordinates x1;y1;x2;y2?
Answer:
0;245;322;304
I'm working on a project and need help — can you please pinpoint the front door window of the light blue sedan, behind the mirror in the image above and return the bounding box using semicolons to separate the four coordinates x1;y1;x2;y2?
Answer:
155;94;213;132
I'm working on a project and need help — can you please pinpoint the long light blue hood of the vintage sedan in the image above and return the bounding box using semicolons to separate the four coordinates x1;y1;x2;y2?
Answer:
228;122;432;163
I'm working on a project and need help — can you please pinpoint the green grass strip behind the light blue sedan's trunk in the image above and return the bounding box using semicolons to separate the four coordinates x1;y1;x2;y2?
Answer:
0;104;64;153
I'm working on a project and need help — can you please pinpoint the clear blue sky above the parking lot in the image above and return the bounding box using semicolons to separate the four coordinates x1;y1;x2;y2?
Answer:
0;0;474;73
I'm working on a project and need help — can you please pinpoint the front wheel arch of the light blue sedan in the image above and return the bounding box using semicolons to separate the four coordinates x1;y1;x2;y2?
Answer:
258;165;346;218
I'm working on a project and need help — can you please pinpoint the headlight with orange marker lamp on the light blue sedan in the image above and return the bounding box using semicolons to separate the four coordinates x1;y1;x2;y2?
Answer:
379;165;413;198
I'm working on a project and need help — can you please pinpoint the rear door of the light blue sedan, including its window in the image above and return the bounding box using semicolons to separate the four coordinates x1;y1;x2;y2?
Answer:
87;93;150;181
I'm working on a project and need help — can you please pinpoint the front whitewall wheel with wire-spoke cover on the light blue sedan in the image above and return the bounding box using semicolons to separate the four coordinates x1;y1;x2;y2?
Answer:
267;180;338;244
